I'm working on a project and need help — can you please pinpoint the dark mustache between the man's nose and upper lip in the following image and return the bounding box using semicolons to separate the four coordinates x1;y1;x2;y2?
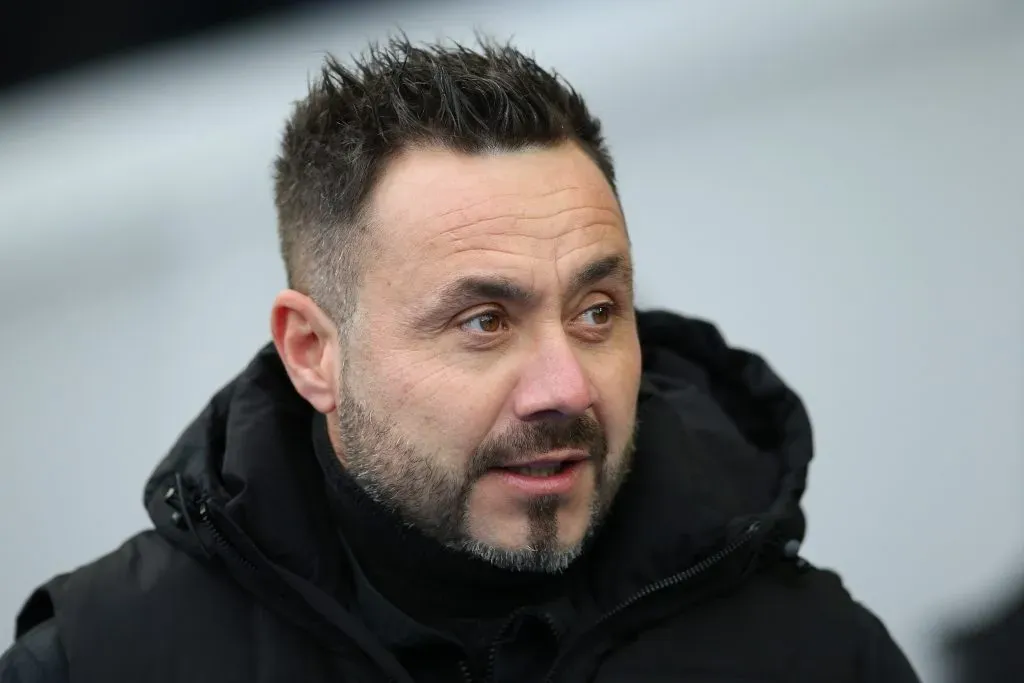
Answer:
471;415;608;477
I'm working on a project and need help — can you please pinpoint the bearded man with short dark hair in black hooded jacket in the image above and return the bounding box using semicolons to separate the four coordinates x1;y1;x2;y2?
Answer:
0;39;916;683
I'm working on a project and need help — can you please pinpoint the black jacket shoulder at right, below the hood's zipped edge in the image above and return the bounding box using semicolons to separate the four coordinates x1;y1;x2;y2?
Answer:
608;562;920;683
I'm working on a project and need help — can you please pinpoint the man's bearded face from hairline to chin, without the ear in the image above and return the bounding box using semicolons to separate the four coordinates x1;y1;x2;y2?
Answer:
337;145;640;571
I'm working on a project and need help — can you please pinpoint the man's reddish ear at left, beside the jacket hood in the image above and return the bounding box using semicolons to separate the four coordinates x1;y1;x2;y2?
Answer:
270;290;341;415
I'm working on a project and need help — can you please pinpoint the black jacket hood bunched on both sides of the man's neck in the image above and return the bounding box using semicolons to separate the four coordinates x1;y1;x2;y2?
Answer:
144;311;812;602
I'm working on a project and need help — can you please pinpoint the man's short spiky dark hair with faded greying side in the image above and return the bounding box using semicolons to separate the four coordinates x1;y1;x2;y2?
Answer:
274;35;615;325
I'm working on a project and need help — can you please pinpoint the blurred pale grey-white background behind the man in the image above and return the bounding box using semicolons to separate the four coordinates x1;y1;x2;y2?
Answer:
0;0;1024;681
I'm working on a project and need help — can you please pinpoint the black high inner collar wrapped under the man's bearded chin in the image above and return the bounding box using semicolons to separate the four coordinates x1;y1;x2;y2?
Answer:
313;416;580;621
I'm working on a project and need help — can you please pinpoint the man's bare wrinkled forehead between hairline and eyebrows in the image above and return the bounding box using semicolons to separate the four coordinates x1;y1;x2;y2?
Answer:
365;147;632;319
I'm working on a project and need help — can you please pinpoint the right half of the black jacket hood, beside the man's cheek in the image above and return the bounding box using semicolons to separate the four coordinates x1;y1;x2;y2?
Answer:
596;311;813;599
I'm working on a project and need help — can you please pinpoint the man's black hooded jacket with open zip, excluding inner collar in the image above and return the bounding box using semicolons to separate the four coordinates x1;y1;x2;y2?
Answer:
0;312;918;683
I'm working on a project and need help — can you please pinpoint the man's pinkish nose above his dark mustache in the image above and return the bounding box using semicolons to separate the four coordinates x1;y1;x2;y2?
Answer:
514;333;594;421
